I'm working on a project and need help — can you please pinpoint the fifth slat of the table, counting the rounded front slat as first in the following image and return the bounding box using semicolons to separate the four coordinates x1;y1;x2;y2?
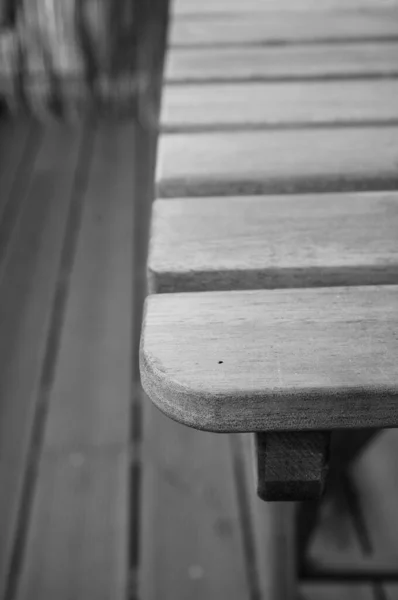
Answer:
165;42;398;85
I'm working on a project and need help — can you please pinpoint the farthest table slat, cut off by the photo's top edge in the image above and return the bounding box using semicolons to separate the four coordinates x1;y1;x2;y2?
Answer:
172;0;397;16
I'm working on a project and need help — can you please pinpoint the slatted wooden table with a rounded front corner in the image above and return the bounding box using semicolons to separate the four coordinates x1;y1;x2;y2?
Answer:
141;0;398;598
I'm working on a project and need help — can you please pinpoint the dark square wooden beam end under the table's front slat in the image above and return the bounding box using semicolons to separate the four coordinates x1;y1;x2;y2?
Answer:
254;431;331;501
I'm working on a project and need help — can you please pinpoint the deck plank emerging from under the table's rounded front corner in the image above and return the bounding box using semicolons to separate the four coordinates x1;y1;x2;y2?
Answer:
139;398;250;600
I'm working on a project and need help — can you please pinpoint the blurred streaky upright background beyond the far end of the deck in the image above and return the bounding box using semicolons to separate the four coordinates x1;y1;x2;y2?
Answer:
0;0;138;117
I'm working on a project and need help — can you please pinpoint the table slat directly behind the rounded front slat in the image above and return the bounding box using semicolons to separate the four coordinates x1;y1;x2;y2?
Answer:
148;192;398;293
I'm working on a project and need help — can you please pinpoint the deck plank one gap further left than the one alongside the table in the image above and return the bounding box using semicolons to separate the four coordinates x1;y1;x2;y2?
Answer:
0;128;80;597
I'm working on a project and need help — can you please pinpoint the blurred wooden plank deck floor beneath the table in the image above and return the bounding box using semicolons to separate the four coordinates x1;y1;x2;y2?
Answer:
0;112;398;600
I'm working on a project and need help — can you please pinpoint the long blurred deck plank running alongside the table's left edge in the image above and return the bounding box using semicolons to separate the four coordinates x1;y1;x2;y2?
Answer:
17;125;134;600
